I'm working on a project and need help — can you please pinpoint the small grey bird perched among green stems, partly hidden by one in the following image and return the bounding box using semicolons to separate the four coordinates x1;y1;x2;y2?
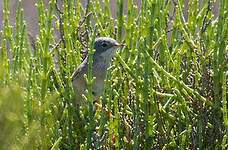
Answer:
71;37;124;105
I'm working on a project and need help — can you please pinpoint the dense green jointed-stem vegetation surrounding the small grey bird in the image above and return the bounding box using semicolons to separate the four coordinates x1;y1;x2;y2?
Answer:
0;0;228;150
